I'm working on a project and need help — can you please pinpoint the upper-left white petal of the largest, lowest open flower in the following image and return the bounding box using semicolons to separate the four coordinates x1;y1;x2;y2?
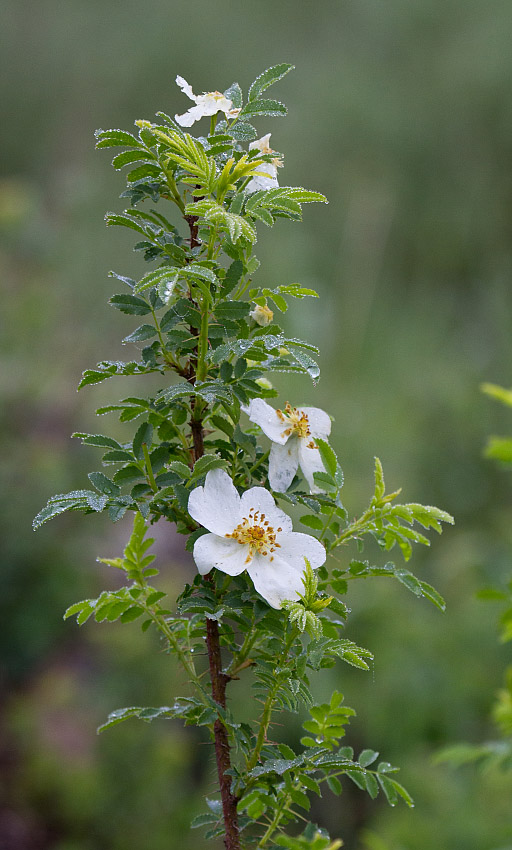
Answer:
188;469;240;535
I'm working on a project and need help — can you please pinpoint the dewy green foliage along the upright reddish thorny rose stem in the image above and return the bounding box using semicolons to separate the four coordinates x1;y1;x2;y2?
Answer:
34;63;453;850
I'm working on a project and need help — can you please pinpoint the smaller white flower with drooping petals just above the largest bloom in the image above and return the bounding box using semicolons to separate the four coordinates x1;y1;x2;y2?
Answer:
246;398;331;493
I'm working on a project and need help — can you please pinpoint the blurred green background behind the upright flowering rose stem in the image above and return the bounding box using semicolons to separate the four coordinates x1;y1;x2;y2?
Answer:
0;0;512;850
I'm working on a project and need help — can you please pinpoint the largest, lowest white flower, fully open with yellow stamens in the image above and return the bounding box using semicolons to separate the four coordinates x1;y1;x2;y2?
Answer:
188;469;326;608
